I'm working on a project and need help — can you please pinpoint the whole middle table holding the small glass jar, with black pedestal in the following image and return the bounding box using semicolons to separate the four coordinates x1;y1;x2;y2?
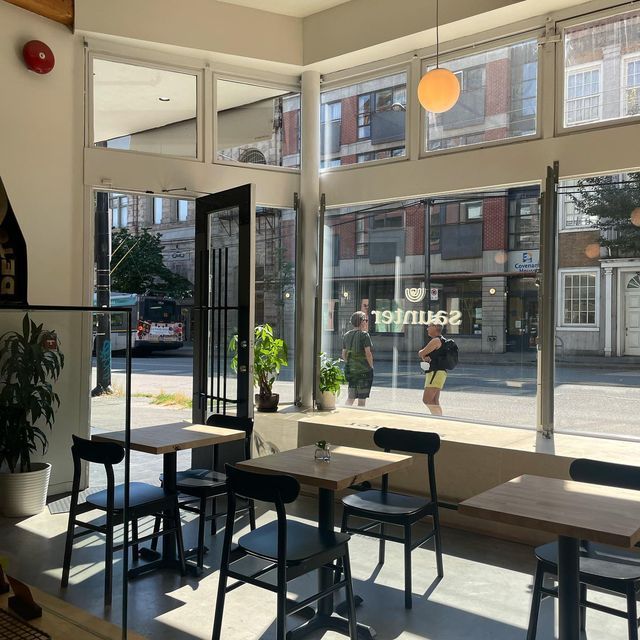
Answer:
237;445;413;640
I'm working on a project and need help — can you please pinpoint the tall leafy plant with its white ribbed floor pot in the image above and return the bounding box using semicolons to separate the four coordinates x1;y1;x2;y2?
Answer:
0;314;64;517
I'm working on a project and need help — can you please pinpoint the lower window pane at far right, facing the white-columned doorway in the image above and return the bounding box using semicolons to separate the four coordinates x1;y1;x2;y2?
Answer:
555;173;640;437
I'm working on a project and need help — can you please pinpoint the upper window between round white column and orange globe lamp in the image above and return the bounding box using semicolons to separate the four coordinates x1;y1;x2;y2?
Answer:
320;72;407;169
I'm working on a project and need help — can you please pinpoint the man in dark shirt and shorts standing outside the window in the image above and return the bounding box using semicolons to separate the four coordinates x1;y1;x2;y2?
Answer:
342;311;373;407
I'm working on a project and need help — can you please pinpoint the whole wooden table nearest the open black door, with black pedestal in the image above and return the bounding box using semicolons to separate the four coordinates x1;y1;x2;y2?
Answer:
91;422;246;577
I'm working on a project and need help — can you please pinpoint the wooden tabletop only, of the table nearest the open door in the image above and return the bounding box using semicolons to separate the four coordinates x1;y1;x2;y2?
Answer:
91;422;245;455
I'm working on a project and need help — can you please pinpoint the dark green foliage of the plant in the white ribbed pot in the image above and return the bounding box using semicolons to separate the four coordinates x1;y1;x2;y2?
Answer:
0;314;64;473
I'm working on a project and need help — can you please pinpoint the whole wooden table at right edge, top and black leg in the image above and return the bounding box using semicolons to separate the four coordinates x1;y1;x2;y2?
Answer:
459;475;640;640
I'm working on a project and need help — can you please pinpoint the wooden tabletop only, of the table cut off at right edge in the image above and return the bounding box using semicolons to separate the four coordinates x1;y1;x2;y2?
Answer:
459;475;640;547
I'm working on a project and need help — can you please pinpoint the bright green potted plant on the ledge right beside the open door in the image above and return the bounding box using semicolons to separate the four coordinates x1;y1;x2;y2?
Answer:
229;323;288;411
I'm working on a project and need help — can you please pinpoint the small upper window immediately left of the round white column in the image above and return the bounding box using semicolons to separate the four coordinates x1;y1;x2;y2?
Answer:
216;80;300;169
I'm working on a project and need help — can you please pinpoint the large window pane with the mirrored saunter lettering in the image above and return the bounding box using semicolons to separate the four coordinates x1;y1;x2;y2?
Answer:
322;188;539;427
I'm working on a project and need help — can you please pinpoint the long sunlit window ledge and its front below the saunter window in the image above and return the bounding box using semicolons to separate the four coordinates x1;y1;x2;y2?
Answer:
255;407;640;544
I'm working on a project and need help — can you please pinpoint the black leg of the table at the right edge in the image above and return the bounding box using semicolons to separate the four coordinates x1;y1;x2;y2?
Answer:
558;536;580;640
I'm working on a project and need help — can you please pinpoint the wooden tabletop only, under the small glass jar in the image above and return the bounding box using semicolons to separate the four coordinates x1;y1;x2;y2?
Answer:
237;445;413;491
